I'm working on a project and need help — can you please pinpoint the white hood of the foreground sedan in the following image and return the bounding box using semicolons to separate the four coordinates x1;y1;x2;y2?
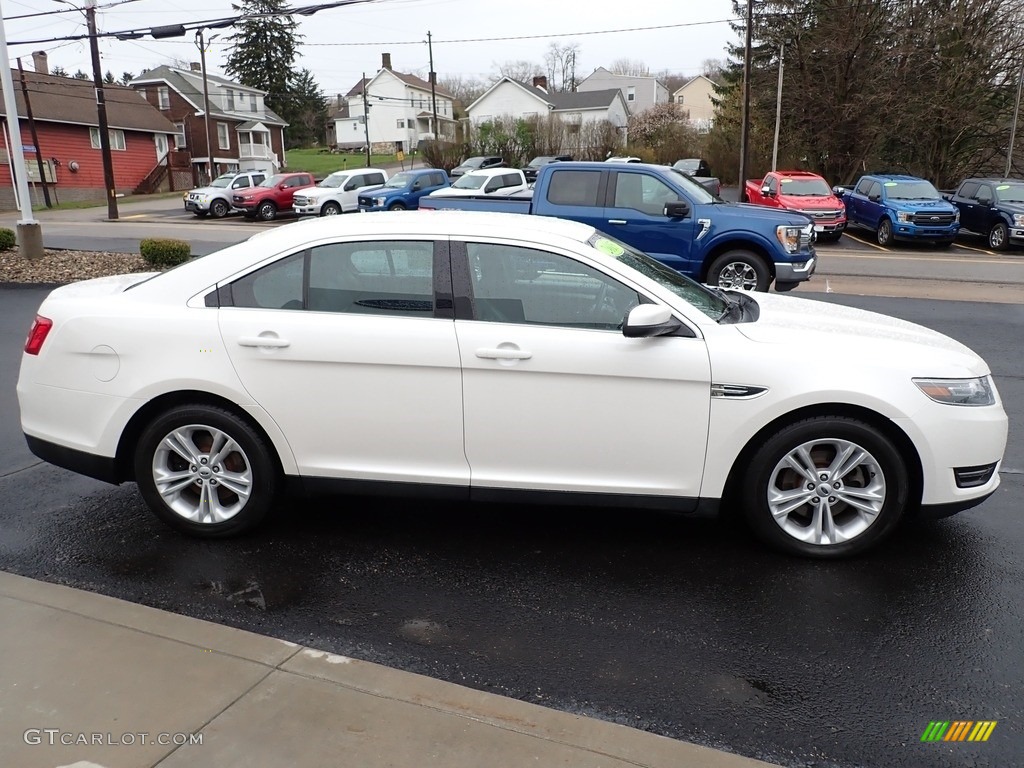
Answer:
735;293;989;377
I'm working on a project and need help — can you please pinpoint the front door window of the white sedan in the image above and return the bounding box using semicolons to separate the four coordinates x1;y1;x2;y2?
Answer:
466;243;640;330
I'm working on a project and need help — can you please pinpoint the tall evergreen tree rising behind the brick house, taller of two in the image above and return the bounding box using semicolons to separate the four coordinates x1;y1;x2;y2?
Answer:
224;0;302;128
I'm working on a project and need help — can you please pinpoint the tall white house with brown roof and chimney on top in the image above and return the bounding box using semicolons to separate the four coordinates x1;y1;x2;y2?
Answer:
334;53;456;154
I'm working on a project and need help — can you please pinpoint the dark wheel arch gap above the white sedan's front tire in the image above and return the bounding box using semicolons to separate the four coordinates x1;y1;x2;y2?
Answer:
722;402;925;508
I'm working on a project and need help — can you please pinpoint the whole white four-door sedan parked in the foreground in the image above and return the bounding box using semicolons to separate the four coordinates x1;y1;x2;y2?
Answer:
17;211;1007;557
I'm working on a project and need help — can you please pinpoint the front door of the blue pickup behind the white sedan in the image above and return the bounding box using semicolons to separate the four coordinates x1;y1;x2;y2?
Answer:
598;168;699;274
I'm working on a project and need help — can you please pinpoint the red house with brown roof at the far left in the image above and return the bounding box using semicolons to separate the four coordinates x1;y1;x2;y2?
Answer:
0;54;174;210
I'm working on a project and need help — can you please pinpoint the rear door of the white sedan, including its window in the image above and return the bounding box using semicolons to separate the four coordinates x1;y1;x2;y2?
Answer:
219;238;469;486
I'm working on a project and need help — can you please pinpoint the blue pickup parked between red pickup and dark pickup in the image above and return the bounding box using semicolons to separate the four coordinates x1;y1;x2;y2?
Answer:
836;173;959;246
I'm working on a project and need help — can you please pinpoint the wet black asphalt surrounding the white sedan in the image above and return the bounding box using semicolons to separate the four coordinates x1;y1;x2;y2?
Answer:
0;289;1024;767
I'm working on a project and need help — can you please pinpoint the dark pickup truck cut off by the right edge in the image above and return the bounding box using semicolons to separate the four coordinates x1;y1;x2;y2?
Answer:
943;178;1024;251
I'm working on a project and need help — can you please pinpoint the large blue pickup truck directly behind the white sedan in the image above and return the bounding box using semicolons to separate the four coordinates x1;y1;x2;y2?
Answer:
420;162;816;291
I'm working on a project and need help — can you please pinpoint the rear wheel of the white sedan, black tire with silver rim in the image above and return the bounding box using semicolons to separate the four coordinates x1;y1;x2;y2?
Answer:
134;404;280;539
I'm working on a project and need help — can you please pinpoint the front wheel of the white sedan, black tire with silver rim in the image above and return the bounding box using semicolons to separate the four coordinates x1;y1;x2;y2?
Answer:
735;416;910;558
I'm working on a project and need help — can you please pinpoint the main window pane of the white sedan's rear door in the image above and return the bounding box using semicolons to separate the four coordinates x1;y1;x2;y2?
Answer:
307;241;434;317
